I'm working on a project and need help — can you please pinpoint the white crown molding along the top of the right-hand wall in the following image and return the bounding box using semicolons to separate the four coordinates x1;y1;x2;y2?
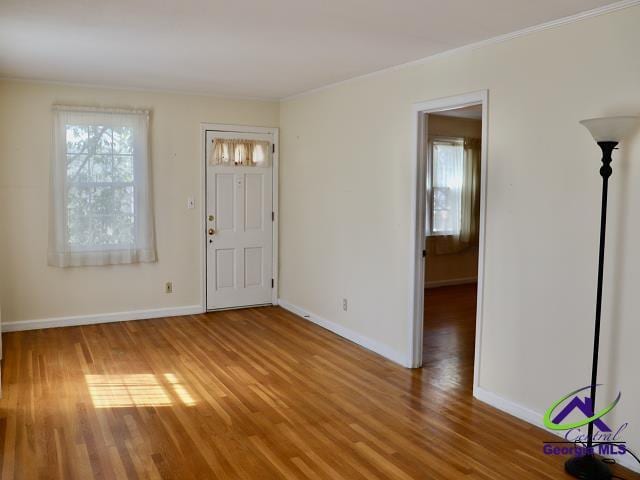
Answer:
280;0;640;102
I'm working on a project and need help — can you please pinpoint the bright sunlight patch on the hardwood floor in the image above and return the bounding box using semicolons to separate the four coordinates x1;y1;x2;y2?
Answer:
85;373;196;408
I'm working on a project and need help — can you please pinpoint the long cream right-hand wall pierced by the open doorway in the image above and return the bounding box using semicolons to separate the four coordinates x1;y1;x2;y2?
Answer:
280;2;640;449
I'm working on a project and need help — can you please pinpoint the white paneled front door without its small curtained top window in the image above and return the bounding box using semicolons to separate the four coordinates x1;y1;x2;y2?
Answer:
205;131;273;310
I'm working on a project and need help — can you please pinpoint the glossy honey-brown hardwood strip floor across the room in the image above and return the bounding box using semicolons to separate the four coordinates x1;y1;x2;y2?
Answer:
0;298;638;480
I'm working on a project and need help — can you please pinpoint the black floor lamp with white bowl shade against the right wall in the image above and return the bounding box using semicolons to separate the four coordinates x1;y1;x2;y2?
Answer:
565;117;638;480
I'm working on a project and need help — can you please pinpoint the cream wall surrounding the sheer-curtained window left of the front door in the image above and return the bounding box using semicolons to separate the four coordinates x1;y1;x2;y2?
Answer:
0;81;279;322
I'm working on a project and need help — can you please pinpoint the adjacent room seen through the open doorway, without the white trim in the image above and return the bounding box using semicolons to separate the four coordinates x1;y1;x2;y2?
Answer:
422;104;483;397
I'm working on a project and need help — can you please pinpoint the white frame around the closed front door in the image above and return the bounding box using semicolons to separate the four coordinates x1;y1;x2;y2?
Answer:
200;123;280;312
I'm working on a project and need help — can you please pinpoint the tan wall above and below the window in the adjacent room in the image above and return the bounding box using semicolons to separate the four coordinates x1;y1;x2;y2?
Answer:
425;115;482;287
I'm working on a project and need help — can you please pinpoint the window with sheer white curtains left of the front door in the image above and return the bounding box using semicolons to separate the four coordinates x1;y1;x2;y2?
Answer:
49;107;156;267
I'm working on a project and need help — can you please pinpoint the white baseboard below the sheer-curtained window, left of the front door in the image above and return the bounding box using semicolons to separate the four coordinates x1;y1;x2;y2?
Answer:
2;305;203;332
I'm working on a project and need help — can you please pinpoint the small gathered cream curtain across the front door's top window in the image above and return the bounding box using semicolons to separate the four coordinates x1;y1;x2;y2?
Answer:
209;138;271;167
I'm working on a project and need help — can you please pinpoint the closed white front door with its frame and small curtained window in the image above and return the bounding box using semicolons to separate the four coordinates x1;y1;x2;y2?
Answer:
201;124;278;311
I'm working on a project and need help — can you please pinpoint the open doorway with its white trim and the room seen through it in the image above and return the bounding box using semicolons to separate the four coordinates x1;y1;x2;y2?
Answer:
410;92;487;400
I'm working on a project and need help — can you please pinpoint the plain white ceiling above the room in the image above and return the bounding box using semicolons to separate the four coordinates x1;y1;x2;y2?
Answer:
0;0;614;99
